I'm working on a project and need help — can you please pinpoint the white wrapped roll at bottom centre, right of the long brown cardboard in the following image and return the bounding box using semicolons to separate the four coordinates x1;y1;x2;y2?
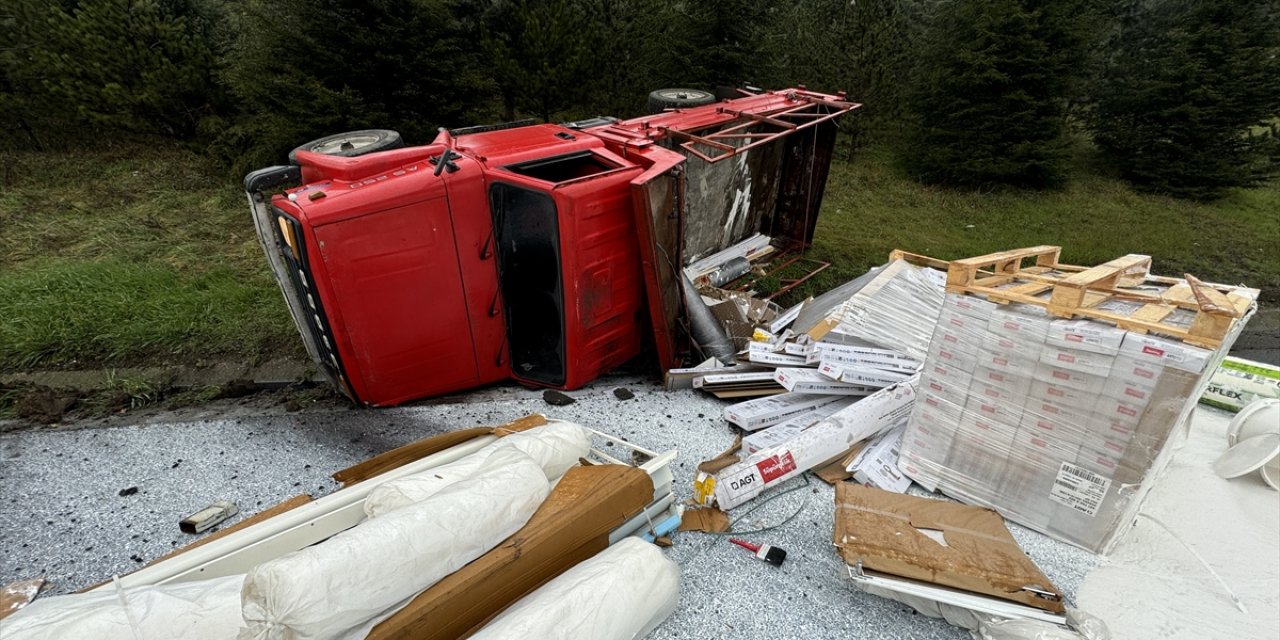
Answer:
471;538;680;640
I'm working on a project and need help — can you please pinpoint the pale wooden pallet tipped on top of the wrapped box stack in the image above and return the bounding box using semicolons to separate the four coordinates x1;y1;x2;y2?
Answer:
890;246;1258;348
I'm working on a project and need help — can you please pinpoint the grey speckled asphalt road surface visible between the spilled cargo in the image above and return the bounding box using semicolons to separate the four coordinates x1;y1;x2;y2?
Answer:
0;378;1098;640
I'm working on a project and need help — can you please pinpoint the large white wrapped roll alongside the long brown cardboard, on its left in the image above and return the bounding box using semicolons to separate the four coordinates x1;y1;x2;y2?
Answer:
239;452;549;640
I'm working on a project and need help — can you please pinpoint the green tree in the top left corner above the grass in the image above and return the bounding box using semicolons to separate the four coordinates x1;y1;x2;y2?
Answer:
0;0;220;145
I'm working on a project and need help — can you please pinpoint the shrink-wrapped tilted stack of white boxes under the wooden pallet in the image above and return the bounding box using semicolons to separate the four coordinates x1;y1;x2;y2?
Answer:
900;293;1234;550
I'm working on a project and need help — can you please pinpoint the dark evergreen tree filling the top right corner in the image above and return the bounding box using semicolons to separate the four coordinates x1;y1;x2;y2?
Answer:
1092;0;1280;200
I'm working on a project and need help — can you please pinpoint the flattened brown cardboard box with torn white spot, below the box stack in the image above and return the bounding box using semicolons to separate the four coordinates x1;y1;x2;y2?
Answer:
833;483;1065;613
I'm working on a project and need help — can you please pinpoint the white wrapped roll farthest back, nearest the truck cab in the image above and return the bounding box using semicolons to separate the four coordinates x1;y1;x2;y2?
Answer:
365;420;591;517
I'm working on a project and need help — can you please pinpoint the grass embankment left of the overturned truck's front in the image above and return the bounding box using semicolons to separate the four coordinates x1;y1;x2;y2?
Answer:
0;140;301;372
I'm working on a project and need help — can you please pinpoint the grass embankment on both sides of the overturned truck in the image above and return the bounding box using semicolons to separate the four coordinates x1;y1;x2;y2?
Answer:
0;146;1280;371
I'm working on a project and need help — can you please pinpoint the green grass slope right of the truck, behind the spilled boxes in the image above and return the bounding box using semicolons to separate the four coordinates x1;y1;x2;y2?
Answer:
791;150;1280;305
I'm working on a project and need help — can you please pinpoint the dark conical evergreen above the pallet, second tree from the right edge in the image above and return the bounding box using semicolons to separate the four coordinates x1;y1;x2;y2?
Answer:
905;0;1082;188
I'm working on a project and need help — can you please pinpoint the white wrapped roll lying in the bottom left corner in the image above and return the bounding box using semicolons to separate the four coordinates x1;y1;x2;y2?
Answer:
0;575;244;640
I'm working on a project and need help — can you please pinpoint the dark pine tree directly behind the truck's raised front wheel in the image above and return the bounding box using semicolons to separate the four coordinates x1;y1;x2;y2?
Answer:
221;0;494;169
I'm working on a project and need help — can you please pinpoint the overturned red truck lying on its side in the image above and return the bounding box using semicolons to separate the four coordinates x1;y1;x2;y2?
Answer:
244;87;859;406
